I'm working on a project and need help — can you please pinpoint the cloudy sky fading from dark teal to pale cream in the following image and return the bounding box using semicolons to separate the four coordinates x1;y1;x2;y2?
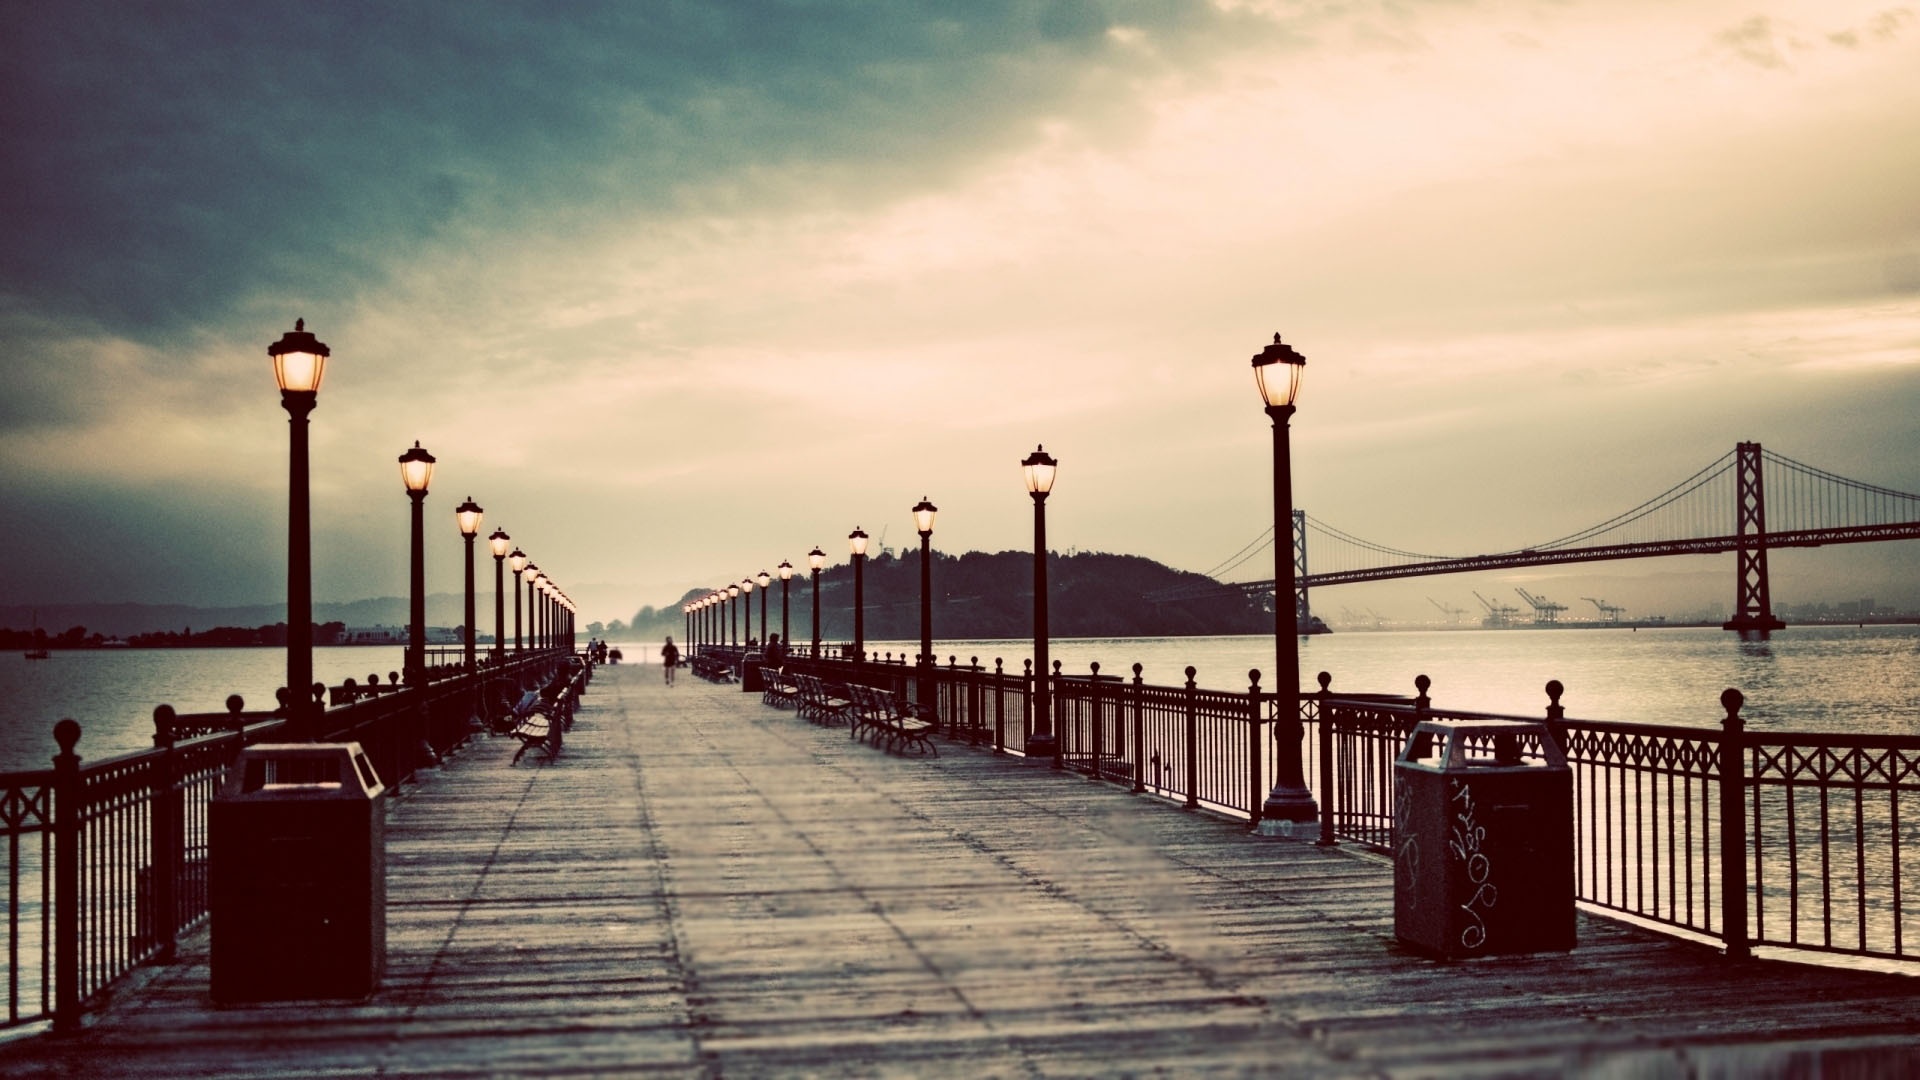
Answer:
0;0;1920;621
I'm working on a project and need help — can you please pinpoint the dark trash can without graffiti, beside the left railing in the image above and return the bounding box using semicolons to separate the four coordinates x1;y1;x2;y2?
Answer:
207;742;386;1005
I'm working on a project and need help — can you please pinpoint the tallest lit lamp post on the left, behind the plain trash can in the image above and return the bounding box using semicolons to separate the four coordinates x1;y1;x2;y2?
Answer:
267;319;332;726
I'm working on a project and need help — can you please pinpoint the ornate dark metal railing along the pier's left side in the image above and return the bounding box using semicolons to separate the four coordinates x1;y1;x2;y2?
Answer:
0;651;566;1028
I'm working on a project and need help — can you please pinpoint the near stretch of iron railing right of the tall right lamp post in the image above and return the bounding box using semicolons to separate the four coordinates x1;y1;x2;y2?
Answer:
1304;682;1920;961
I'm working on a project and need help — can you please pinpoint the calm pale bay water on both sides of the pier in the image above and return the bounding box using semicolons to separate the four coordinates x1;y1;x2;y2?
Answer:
0;626;1920;771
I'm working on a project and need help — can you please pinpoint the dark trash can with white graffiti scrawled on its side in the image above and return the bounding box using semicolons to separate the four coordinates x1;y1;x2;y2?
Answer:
1394;719;1574;959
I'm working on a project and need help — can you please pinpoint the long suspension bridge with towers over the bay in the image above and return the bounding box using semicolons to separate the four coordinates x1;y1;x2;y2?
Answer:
1148;442;1920;634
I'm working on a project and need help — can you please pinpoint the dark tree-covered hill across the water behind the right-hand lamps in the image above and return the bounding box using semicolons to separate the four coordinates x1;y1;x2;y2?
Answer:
626;552;1273;642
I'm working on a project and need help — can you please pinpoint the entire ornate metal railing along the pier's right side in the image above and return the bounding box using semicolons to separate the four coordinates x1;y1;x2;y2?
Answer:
771;657;1920;961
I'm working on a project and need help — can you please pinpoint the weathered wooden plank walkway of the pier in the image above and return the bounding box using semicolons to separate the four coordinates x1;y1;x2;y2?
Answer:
0;667;1920;1078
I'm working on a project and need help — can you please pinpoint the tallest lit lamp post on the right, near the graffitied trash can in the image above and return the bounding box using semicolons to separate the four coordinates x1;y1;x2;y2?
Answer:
1254;334;1319;836
